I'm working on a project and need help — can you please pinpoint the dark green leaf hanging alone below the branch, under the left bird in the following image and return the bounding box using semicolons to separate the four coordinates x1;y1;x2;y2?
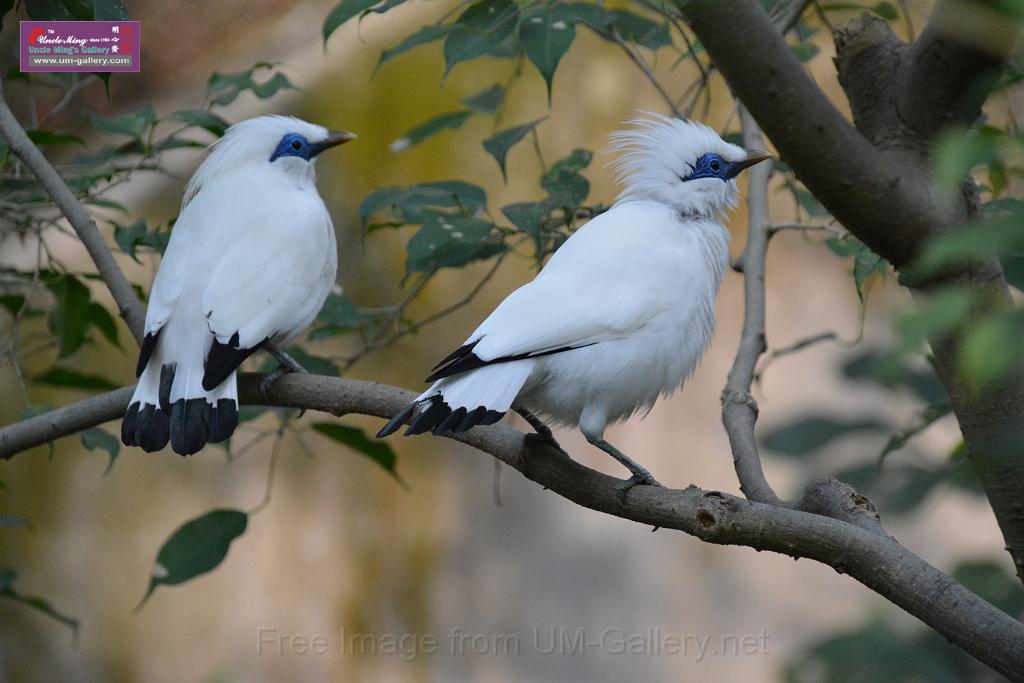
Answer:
135;509;249;611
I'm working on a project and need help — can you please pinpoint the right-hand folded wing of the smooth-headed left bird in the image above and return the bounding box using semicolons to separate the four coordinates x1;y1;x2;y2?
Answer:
201;183;335;386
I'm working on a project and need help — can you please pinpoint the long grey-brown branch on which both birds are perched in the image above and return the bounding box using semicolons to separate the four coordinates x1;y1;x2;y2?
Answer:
0;375;1024;679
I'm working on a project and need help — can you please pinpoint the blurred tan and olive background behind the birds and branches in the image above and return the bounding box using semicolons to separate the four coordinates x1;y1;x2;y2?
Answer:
0;0;1020;682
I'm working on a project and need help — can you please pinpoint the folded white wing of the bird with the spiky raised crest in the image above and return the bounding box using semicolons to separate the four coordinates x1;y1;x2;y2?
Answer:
428;205;663;381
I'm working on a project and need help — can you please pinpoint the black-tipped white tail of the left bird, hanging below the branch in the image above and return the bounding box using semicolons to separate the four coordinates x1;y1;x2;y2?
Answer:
121;333;239;456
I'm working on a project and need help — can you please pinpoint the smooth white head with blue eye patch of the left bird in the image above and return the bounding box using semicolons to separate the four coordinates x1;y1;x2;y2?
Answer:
185;115;355;202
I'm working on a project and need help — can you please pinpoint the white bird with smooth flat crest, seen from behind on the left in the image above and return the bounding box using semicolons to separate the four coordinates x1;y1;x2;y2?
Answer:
121;116;355;455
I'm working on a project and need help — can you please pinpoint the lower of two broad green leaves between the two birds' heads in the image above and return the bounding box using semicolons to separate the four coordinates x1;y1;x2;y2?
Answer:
406;216;504;274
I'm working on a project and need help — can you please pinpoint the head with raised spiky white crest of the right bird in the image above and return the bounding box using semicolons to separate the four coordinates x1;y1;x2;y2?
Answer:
608;114;771;216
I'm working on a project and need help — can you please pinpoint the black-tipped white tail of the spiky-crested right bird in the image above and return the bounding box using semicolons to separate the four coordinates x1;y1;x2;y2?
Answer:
377;359;536;438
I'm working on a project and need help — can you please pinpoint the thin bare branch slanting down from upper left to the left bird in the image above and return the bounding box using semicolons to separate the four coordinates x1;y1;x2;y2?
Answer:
0;80;145;341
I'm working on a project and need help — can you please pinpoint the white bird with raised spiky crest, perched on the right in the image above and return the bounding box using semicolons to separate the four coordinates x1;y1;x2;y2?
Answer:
378;115;770;492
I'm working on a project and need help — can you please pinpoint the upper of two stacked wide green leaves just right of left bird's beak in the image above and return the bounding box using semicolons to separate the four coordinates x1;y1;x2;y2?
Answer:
359;180;487;225
